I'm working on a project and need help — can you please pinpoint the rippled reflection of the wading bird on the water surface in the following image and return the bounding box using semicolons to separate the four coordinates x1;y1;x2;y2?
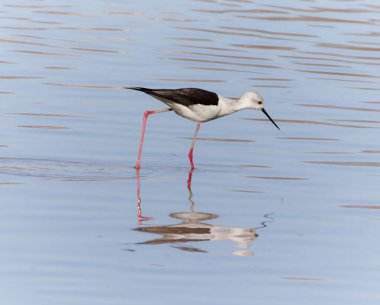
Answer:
135;170;258;256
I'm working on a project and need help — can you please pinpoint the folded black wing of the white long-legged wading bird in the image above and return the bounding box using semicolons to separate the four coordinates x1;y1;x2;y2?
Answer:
125;87;219;107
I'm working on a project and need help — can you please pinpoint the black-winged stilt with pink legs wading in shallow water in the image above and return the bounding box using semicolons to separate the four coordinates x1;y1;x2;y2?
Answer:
124;87;280;169
